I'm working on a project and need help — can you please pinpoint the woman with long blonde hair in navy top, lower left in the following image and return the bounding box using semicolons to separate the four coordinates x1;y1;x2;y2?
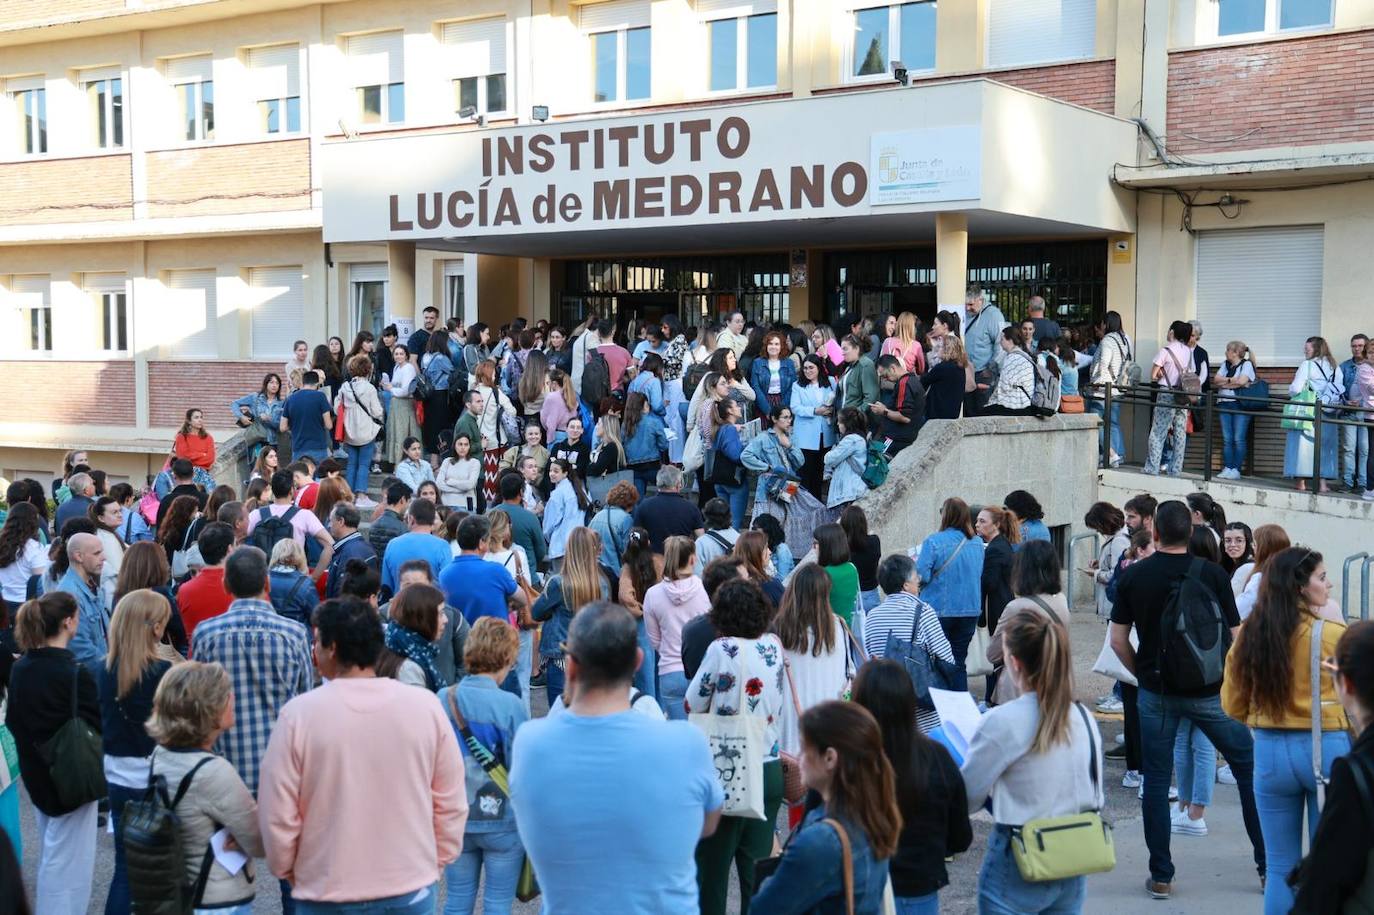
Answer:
96;589;181;912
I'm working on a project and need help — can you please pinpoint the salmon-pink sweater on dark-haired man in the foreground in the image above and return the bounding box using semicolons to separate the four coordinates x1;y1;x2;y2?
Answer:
258;677;467;903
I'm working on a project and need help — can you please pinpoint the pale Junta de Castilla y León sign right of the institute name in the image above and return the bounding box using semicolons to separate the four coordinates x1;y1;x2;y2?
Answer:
868;125;982;206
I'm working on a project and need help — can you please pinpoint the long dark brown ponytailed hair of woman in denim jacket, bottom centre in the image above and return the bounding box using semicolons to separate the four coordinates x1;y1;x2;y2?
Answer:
801;699;901;860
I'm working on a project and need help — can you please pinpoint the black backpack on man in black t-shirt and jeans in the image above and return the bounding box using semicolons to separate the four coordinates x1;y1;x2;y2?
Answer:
1160;558;1231;692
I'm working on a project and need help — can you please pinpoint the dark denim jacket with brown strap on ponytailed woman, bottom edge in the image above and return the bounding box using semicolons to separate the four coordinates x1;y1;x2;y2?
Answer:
750;806;888;915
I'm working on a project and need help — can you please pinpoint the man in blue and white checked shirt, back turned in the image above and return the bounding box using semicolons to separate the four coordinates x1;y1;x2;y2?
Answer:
191;547;315;794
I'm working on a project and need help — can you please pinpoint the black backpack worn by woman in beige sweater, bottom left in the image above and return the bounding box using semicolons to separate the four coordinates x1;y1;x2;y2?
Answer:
120;756;220;915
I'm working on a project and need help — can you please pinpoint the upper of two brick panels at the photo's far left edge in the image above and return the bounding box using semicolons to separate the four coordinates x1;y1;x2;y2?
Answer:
0;155;133;225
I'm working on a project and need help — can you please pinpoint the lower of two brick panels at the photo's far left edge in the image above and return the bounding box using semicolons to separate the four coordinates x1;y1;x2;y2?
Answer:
0;360;135;426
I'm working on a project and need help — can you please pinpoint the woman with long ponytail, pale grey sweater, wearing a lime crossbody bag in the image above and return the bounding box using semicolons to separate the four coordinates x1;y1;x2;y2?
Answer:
962;601;1105;912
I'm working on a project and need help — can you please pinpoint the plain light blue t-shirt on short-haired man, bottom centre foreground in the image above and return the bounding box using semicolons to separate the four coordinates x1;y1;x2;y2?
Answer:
510;710;724;915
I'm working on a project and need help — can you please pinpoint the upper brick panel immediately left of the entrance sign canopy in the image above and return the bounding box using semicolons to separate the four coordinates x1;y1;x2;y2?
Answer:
148;139;311;217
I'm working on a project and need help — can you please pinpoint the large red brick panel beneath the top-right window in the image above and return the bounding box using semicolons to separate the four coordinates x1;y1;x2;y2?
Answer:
1167;30;1374;154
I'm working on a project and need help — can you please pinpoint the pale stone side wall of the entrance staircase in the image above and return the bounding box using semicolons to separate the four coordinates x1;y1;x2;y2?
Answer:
859;415;1099;552
